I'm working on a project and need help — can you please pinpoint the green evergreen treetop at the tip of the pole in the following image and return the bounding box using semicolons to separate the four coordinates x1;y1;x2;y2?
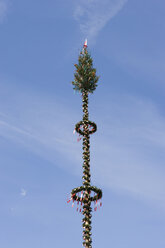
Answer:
72;48;99;93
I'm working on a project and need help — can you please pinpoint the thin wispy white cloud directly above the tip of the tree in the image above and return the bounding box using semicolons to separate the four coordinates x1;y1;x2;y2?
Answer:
74;0;127;40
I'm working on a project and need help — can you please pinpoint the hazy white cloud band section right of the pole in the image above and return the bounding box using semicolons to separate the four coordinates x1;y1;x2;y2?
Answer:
92;96;165;208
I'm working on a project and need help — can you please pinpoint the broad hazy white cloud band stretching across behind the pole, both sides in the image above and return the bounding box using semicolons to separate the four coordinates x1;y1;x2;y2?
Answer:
0;83;165;207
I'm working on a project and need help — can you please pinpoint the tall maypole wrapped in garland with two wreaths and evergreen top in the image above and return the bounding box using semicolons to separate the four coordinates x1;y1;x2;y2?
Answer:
68;40;102;248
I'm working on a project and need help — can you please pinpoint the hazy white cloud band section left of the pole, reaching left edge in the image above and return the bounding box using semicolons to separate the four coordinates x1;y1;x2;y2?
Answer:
0;82;81;173
